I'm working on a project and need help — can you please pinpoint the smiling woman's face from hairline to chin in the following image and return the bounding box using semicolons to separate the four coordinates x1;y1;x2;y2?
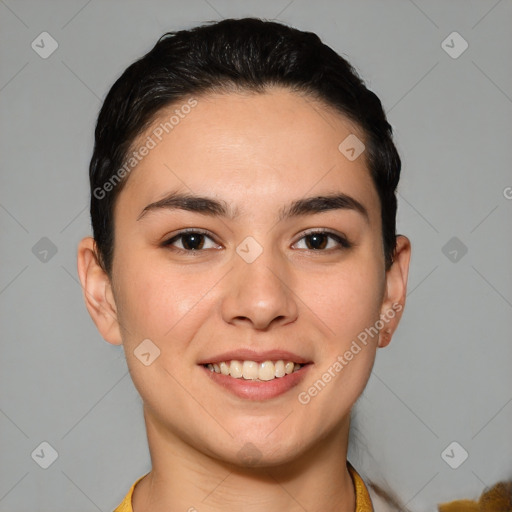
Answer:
80;89;410;465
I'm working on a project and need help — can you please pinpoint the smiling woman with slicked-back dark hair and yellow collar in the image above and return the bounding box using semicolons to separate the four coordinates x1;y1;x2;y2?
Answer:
78;19;411;512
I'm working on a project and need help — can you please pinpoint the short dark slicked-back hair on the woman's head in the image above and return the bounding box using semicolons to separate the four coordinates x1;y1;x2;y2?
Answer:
89;18;401;275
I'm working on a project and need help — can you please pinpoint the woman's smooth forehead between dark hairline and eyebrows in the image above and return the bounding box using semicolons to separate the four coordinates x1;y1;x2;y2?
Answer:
118;88;378;222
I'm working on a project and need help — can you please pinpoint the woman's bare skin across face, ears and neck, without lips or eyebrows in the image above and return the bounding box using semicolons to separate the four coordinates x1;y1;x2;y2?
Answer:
78;88;410;512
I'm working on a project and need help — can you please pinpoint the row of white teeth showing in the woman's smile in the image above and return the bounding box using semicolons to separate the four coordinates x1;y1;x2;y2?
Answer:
206;359;303;381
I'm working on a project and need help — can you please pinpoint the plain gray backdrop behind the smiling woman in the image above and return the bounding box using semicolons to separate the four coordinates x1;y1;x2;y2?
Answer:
0;0;512;512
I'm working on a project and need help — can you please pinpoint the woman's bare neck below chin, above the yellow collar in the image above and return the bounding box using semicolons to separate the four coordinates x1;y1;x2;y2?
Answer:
132;409;355;512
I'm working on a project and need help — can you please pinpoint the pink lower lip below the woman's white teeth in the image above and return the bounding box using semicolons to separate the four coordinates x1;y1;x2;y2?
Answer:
201;363;311;400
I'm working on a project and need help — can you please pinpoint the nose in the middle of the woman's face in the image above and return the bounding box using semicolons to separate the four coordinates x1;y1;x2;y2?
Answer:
222;245;298;330
